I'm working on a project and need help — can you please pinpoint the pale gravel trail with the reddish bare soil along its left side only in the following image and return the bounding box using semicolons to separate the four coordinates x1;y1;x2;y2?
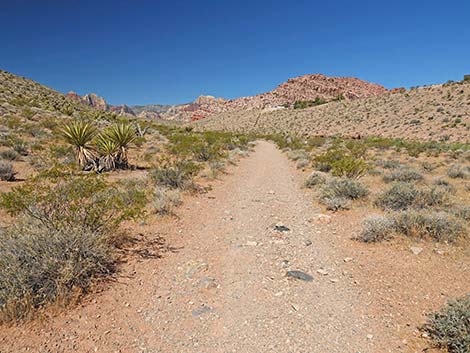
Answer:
0;142;412;353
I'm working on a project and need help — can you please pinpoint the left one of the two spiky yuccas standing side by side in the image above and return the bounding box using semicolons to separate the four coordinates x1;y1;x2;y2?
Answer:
61;121;96;168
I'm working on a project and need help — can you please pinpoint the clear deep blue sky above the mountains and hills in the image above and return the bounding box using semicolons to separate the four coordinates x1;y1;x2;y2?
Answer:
0;0;470;105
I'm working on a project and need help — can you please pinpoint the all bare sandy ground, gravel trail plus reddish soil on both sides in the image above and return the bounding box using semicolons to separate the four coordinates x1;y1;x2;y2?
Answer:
0;142;470;353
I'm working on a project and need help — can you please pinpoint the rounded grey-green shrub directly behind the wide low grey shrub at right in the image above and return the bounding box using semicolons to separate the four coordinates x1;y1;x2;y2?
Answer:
375;182;418;211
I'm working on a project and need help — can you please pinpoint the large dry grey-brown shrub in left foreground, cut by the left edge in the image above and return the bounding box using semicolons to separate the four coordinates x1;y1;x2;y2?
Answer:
0;222;114;321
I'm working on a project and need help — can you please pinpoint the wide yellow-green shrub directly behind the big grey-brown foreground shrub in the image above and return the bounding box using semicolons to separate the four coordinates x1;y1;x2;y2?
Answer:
0;176;146;233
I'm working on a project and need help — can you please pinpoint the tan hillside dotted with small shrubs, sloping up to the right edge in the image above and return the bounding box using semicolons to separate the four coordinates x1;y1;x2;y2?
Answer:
195;80;470;142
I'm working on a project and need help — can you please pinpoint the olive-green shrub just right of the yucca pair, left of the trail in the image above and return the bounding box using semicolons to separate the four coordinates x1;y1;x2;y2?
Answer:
150;159;201;189
